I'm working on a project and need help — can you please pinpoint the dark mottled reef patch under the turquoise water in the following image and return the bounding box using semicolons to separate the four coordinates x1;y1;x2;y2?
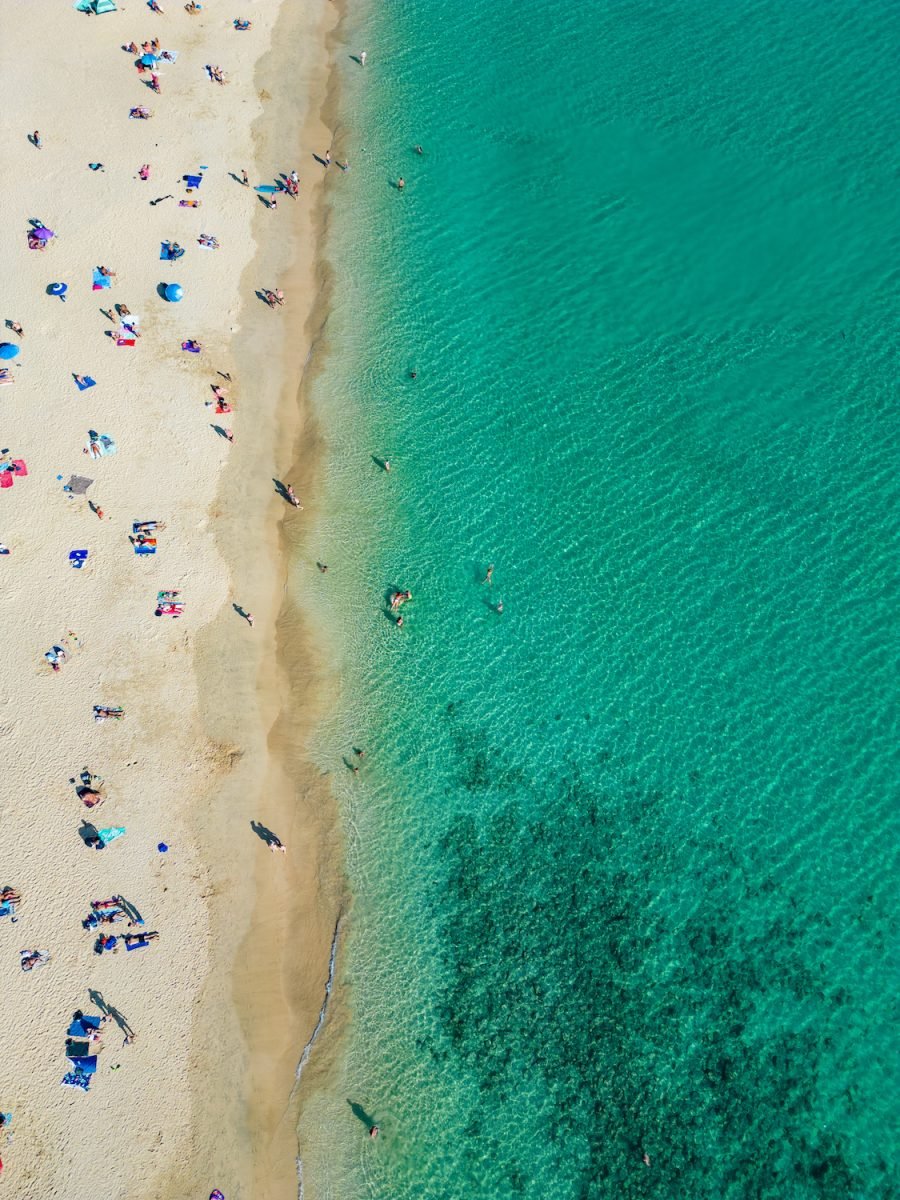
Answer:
432;744;896;1200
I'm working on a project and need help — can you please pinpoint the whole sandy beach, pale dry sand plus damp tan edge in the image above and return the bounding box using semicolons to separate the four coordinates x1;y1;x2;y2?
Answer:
0;0;341;1200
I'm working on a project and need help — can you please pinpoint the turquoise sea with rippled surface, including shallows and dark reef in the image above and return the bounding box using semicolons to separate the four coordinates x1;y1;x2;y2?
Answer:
298;0;900;1200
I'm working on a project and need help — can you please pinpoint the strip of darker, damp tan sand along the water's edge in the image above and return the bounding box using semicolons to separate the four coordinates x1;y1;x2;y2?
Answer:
192;5;344;1200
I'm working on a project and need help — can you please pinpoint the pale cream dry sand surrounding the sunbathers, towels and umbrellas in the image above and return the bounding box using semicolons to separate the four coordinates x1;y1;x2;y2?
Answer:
0;0;332;1200
